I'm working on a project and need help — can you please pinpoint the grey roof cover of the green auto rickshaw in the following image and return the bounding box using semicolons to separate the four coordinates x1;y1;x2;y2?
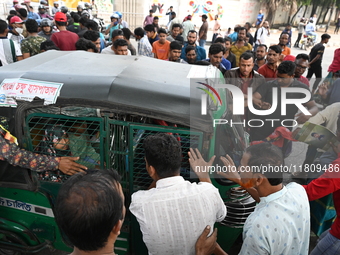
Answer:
0;51;217;131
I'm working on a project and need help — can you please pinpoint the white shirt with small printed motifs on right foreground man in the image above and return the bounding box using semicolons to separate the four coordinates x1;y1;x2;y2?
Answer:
240;182;310;255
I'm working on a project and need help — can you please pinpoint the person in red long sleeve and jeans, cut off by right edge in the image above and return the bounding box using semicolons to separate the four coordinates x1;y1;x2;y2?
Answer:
303;114;340;255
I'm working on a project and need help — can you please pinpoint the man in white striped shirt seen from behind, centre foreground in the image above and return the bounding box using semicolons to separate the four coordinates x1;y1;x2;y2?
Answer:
130;133;226;255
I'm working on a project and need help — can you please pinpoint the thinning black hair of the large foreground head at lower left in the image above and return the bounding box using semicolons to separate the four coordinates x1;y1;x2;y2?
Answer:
55;170;124;251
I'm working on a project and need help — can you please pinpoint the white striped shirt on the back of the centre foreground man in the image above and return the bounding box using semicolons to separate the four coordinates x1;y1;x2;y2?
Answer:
130;176;226;255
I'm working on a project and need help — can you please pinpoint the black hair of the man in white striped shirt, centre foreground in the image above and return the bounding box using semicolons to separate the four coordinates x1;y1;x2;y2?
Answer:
143;133;182;178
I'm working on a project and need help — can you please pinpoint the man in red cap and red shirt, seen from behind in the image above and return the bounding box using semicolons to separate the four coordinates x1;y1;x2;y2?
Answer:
51;12;79;50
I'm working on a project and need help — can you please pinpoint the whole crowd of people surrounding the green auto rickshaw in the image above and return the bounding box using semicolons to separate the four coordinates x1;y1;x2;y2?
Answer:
0;0;340;255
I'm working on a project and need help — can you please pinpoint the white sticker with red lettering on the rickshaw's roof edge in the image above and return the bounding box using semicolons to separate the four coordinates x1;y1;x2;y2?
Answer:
0;78;63;107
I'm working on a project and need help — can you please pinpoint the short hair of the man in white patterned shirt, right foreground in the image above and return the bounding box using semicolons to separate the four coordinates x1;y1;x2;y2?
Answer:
246;142;283;186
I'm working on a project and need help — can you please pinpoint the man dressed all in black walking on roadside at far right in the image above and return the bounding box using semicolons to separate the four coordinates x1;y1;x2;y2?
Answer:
307;34;331;94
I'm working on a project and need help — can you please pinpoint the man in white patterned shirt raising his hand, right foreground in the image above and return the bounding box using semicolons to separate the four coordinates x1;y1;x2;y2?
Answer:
220;143;310;255
